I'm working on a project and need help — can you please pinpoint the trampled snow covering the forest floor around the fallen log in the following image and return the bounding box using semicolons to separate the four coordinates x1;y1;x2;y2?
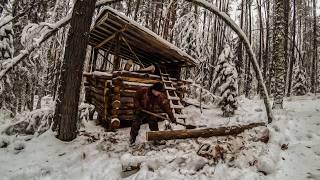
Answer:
0;95;320;180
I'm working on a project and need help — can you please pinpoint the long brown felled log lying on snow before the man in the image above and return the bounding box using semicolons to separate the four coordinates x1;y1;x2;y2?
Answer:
146;122;266;141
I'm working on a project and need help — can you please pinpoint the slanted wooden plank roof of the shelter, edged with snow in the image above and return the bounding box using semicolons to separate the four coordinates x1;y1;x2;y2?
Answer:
89;7;198;66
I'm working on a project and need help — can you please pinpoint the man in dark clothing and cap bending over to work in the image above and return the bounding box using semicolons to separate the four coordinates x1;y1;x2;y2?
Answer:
130;82;176;144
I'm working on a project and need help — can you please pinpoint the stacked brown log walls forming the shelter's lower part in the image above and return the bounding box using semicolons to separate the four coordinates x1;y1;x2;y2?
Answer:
84;70;188;129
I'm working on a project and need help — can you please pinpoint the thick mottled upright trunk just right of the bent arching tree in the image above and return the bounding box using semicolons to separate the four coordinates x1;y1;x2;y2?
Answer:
273;0;288;109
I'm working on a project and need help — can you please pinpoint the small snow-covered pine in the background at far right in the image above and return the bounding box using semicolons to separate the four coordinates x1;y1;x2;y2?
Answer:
293;65;307;96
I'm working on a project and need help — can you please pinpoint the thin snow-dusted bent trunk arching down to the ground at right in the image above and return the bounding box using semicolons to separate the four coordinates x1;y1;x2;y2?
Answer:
186;0;274;123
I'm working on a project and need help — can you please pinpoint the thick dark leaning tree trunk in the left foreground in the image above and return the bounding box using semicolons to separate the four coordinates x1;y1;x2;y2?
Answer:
53;0;96;141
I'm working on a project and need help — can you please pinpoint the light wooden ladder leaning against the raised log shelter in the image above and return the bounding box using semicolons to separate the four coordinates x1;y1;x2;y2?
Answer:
158;66;186;122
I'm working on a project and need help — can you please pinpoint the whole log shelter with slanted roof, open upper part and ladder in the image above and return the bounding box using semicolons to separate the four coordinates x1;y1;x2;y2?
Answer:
84;7;198;129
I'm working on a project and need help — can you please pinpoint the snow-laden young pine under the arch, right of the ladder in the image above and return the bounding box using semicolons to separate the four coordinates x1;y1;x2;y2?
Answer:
212;46;238;117
